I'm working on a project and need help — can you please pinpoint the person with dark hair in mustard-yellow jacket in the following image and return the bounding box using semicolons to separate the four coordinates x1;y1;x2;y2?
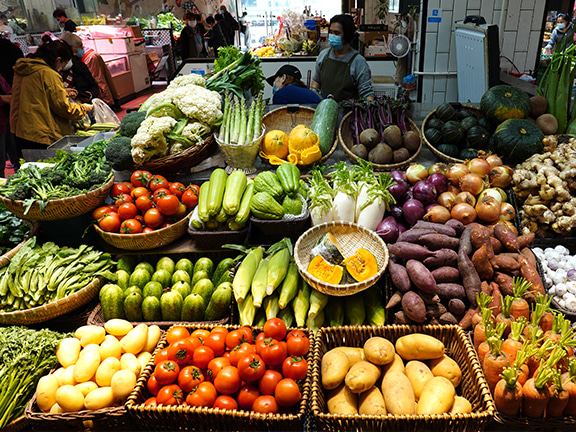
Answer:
10;41;93;152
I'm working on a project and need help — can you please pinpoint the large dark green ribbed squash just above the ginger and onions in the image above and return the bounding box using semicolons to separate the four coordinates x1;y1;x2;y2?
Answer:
493;119;544;163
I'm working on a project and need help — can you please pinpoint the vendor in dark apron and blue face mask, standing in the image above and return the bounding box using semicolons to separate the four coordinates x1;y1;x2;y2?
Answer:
311;15;374;102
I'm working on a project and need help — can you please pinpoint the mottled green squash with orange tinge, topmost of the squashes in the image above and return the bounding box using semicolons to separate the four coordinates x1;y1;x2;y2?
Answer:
480;84;530;124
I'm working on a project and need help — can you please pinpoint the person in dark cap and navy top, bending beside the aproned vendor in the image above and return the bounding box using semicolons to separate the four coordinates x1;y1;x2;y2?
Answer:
266;65;322;104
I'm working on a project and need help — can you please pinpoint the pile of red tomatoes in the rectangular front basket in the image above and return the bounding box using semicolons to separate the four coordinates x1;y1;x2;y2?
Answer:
145;318;310;413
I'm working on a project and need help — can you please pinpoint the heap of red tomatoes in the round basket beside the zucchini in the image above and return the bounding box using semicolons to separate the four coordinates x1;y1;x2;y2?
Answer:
92;170;200;234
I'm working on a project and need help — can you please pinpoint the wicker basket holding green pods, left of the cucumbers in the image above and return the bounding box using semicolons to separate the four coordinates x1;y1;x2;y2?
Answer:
0;277;104;325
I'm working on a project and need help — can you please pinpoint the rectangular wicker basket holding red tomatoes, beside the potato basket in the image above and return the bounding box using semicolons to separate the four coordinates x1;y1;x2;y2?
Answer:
125;325;315;431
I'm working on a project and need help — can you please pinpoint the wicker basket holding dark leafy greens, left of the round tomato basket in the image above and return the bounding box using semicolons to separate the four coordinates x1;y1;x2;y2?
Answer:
0;176;114;220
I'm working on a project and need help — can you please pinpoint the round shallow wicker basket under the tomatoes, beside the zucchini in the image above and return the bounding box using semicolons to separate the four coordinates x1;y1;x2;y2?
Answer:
94;213;192;250
